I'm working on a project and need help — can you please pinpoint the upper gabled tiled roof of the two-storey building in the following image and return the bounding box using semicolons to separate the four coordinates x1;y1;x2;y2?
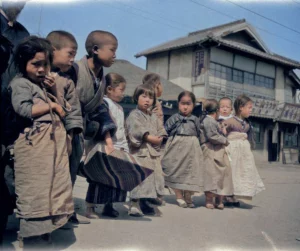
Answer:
135;19;300;68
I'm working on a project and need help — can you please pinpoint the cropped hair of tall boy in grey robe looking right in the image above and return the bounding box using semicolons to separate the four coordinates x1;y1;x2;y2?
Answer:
85;30;118;56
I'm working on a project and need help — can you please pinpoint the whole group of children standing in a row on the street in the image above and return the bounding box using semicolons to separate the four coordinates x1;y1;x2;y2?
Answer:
1;30;264;246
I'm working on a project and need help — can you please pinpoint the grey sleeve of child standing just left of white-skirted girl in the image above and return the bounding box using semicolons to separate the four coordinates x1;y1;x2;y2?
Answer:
204;119;228;145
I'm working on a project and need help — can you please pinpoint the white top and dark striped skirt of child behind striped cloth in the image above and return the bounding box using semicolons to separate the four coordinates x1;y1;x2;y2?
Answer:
86;97;129;204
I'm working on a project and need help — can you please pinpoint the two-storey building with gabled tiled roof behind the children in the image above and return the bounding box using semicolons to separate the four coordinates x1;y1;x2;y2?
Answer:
136;19;300;163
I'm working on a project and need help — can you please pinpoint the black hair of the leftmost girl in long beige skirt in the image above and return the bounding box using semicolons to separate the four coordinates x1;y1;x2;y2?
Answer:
14;36;53;75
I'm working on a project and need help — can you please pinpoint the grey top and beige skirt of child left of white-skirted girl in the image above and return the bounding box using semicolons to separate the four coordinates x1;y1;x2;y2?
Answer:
201;115;233;195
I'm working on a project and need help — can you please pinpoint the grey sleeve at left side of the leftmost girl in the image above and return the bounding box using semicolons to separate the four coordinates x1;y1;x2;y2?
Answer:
10;78;33;119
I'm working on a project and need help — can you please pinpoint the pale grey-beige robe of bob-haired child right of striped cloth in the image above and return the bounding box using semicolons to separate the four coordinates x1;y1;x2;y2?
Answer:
126;109;167;199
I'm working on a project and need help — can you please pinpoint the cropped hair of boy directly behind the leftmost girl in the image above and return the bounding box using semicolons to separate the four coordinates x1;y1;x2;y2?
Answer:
46;30;78;50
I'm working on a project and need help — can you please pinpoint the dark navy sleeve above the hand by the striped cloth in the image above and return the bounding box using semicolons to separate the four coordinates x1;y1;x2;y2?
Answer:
89;103;117;140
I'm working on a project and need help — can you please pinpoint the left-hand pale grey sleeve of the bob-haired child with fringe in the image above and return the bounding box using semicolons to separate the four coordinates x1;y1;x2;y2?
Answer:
126;111;149;147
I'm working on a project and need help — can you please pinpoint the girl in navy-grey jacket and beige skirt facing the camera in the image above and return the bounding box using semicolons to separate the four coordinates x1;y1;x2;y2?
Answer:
162;91;203;208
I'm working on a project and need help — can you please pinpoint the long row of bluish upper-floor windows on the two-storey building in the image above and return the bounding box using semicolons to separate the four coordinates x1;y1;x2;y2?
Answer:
209;62;275;89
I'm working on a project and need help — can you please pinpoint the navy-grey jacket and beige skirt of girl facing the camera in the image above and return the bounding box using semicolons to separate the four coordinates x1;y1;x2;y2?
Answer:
162;113;203;192
